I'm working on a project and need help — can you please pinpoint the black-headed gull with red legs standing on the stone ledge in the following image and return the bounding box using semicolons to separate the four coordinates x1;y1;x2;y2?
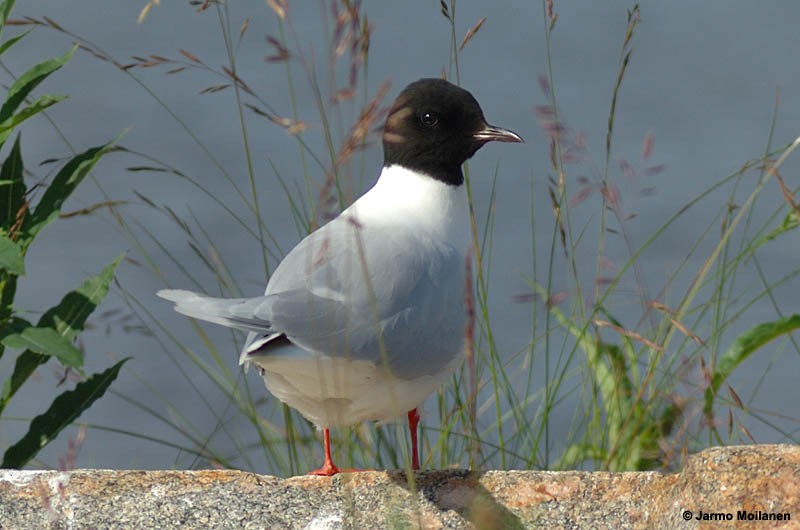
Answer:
157;78;524;476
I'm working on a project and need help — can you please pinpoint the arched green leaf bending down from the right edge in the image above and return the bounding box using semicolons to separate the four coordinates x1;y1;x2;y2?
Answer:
703;314;800;415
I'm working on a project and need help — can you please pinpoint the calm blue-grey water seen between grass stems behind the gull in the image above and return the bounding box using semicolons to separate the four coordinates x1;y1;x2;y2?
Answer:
0;0;800;469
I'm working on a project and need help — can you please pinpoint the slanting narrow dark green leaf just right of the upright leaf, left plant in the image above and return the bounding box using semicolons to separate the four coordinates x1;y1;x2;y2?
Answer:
24;138;118;244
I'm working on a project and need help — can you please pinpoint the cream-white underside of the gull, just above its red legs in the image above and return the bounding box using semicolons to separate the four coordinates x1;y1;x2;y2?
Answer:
249;345;464;428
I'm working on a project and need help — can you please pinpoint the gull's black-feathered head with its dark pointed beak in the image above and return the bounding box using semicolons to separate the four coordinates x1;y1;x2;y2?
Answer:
383;79;523;186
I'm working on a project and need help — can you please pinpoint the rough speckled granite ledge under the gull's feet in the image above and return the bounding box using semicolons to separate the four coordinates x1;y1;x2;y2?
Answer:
0;445;800;530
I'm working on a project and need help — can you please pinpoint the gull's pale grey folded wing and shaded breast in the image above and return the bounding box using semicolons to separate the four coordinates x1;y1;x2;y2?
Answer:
261;218;466;378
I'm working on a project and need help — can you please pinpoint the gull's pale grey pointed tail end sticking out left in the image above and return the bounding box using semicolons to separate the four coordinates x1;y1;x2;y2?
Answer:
156;289;271;333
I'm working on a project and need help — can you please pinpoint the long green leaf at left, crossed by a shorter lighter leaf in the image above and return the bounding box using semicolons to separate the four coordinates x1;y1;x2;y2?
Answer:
0;256;122;413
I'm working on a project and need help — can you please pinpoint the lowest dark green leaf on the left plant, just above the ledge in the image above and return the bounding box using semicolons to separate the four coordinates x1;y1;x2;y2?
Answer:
0;357;130;469
